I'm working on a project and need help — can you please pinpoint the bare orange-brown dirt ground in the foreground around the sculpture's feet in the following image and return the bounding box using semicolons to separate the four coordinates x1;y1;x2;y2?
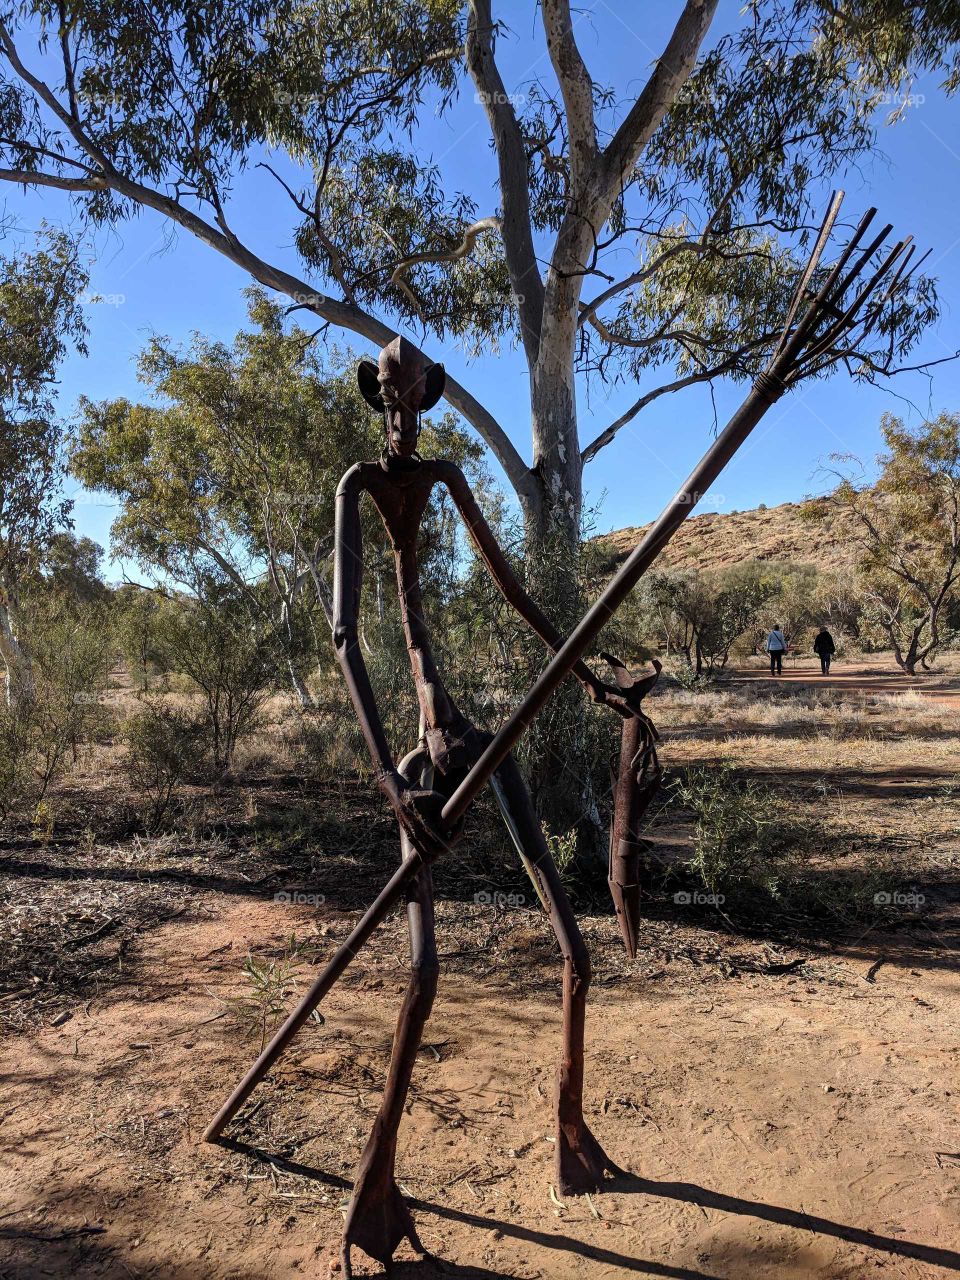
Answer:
0;897;960;1280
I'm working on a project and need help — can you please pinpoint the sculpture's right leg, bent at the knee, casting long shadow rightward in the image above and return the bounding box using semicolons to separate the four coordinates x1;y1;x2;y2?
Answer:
493;756;621;1196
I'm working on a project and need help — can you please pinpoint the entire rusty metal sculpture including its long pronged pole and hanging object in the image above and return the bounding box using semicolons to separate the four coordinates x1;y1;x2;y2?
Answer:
204;193;919;1276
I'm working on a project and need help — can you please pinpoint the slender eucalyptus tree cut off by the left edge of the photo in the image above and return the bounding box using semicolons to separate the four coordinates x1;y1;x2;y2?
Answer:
0;234;87;708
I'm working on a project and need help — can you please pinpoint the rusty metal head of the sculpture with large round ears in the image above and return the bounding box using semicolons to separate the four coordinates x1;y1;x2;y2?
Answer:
357;338;447;458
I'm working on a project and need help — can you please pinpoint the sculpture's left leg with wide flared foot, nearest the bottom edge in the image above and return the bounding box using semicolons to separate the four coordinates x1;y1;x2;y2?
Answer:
342;751;439;1280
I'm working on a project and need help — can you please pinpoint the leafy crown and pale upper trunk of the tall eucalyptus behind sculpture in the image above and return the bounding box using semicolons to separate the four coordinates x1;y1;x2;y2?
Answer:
0;0;960;560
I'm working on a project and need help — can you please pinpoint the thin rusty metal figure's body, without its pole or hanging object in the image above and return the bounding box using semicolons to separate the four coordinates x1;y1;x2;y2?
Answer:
334;338;655;1274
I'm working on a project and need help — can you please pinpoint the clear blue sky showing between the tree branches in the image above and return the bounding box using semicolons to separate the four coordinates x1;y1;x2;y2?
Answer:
0;0;960;577
